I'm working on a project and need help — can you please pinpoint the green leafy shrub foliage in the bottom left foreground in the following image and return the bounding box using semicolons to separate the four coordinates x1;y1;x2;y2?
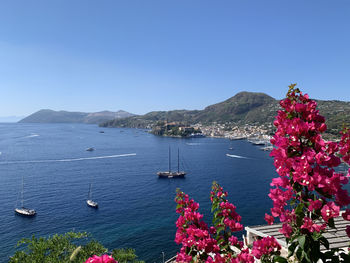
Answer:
9;232;143;263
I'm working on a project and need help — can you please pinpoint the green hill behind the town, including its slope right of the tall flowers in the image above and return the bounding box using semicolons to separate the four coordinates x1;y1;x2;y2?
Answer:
100;92;350;134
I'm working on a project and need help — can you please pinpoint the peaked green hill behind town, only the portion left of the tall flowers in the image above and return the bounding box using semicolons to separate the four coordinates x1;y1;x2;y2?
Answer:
101;92;278;128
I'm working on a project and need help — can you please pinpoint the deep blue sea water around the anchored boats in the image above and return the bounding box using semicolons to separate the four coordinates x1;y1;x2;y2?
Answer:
0;123;276;262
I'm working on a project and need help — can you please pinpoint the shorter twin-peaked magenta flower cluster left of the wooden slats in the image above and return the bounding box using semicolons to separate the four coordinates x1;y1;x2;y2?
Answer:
175;182;281;263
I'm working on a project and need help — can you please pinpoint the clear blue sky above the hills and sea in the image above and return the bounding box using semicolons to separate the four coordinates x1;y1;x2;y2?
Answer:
0;0;350;116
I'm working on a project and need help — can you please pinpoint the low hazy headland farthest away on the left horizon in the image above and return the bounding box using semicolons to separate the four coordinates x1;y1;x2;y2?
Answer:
19;109;134;124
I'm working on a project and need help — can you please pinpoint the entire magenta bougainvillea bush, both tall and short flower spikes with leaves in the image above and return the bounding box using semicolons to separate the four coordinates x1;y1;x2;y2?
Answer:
175;84;350;262
